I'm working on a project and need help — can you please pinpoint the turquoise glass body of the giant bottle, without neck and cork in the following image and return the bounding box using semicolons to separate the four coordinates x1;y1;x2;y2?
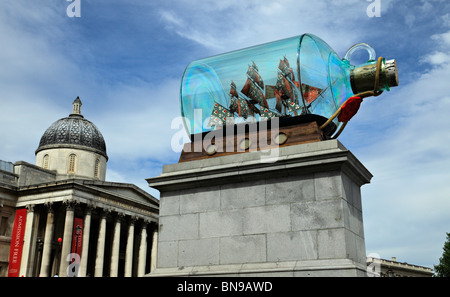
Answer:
180;34;362;135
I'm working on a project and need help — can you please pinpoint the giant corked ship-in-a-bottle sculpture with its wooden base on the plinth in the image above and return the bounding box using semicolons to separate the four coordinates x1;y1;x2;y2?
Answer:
180;34;398;162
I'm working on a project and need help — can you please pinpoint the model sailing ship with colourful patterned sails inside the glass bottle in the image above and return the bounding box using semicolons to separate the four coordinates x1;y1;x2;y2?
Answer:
209;57;324;128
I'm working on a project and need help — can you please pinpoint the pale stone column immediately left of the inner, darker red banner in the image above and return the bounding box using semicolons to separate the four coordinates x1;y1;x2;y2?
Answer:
59;201;75;276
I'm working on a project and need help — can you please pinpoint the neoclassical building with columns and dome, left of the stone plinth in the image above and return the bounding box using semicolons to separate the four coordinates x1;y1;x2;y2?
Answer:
0;98;159;277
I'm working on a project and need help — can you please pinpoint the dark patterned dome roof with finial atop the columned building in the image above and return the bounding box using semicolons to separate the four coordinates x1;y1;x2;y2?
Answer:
36;97;108;159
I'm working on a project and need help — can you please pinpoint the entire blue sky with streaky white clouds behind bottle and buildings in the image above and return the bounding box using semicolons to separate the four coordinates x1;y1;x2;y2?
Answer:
0;0;450;268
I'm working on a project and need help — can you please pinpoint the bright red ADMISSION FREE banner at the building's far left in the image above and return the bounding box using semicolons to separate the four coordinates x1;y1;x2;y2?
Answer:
8;208;27;277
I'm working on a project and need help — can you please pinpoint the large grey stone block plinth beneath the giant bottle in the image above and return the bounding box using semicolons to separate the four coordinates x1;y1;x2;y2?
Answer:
147;140;372;276
